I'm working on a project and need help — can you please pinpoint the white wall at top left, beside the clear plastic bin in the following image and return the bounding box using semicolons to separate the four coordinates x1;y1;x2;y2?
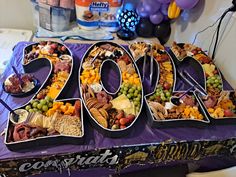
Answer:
0;0;34;30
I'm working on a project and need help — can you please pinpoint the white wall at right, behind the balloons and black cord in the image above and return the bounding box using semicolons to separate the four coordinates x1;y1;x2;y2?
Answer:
168;0;236;88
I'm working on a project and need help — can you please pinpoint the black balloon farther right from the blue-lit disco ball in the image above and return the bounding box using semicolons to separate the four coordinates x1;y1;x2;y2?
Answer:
153;21;171;45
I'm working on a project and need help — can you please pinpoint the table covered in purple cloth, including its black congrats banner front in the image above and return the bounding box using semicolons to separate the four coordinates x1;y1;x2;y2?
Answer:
0;42;236;176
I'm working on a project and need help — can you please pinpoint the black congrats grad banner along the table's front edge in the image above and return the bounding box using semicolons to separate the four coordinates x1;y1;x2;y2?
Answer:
0;139;236;177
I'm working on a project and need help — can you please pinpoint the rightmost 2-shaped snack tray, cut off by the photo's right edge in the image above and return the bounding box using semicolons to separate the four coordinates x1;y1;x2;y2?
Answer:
171;43;236;124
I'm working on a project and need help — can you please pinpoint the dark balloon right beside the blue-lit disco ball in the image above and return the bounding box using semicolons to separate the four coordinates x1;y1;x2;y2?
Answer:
136;18;154;37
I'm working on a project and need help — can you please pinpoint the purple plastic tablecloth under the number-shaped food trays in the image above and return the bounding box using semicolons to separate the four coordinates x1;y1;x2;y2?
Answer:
0;42;236;160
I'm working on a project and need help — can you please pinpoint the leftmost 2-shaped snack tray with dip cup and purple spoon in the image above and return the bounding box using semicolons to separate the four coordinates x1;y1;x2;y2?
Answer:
4;41;84;151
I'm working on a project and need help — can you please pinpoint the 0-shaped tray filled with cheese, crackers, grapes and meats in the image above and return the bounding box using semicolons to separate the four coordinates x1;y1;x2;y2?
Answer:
78;42;143;137
